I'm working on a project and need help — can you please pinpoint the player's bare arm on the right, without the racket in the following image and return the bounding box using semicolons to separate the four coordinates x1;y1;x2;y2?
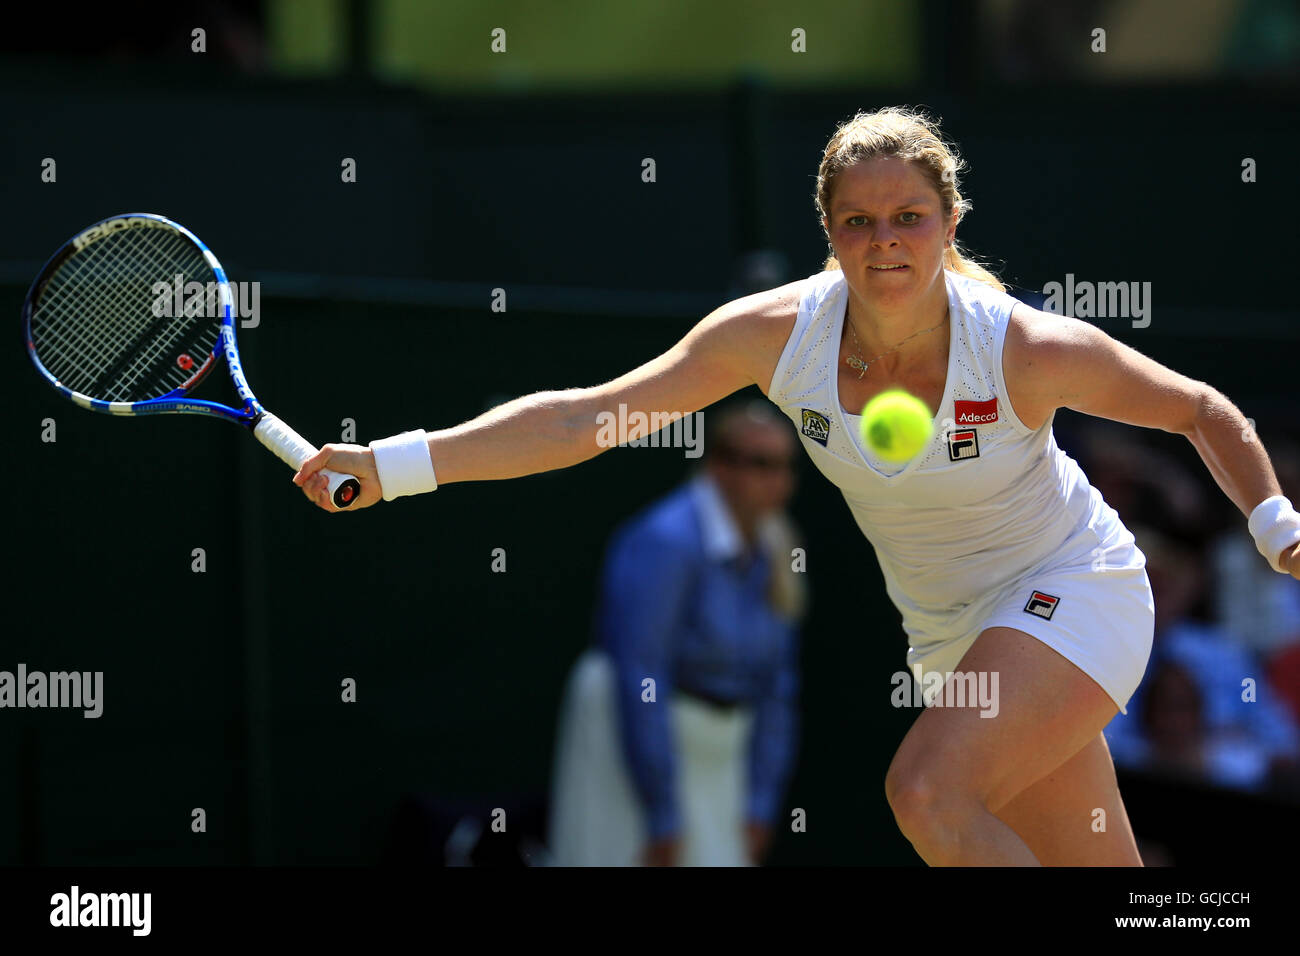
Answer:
1002;304;1300;578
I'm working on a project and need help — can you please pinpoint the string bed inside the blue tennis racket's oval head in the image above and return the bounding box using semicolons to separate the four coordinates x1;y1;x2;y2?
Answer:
31;226;221;402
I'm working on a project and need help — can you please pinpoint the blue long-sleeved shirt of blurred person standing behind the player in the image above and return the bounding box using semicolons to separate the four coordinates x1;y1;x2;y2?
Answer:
595;475;798;839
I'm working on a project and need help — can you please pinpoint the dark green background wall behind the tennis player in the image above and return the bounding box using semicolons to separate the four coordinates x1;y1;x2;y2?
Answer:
0;62;1300;864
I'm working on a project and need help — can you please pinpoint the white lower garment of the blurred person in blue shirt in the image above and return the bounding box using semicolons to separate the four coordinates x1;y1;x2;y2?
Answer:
550;649;754;866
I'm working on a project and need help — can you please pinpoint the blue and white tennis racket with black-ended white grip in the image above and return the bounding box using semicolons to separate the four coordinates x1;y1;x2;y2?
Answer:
22;212;361;509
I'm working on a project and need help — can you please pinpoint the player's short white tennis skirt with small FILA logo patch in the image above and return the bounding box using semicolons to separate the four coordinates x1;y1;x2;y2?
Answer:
907;522;1156;714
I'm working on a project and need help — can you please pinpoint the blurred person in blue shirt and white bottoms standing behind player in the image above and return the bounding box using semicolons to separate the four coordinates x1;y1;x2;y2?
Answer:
550;402;805;866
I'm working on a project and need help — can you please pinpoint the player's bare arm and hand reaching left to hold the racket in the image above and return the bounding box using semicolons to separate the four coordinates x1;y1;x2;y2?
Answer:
294;284;798;511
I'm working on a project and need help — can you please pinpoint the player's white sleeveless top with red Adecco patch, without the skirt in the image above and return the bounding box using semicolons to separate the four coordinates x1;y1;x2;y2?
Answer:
768;271;1140;632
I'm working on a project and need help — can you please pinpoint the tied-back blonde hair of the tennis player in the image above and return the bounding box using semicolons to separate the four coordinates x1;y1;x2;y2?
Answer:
814;107;1006;293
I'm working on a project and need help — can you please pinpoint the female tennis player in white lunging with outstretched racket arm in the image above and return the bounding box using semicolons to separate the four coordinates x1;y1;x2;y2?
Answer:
294;108;1300;865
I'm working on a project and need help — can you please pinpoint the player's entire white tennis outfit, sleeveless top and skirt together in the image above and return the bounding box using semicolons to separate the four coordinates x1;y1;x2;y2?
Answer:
768;269;1154;713
